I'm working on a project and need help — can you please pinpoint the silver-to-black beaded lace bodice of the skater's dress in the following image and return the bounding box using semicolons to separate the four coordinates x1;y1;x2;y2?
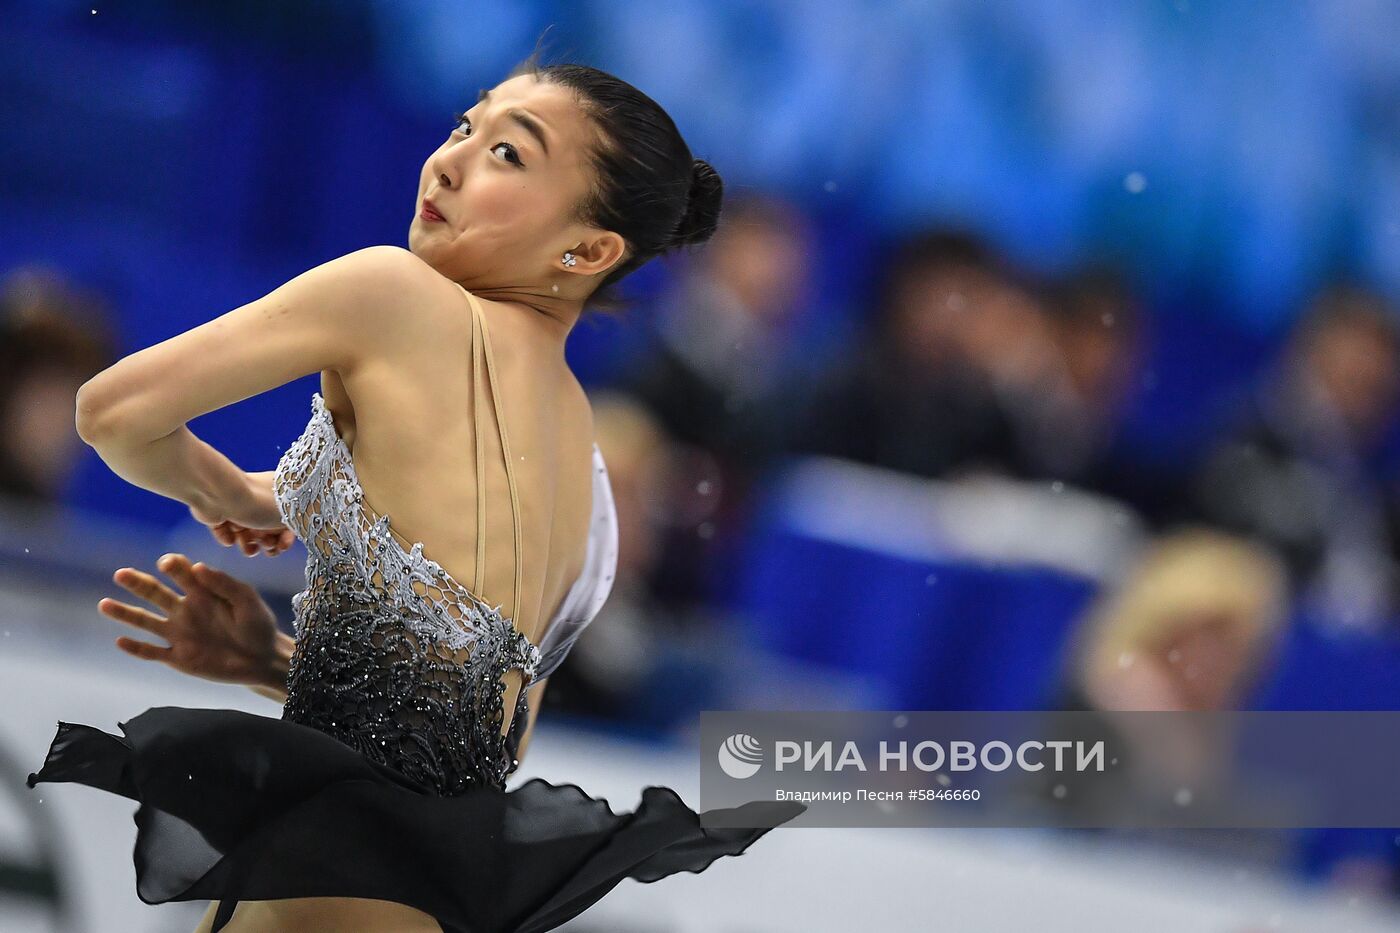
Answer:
273;285;616;794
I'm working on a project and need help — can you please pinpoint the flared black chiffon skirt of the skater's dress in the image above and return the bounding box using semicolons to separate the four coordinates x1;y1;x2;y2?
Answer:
27;706;806;933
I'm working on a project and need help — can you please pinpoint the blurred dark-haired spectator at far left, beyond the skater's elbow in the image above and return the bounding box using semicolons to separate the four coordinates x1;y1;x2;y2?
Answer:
0;268;115;504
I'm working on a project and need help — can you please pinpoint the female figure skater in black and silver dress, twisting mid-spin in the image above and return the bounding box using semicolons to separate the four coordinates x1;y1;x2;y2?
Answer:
29;56;805;932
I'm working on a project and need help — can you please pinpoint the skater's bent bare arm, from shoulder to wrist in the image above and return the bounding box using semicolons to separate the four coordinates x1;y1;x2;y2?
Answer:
76;247;447;515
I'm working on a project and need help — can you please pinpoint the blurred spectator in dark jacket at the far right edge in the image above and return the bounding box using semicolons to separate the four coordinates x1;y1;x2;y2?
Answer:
1191;286;1400;625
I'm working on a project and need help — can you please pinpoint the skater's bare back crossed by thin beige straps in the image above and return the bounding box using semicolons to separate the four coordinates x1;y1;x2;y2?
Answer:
321;279;594;734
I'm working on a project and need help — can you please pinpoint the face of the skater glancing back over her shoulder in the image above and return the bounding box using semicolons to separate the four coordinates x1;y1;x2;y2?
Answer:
409;74;598;289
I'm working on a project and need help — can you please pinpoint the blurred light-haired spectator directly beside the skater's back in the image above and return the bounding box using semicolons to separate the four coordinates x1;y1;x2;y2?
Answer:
545;391;713;727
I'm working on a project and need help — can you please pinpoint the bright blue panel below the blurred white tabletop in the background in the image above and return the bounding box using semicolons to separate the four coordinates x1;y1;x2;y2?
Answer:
735;473;1095;709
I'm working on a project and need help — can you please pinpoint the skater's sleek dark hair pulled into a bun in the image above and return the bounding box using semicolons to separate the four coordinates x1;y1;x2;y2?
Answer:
507;48;724;311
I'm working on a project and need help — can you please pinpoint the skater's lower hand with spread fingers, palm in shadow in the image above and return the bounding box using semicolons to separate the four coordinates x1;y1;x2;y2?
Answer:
98;553;291;686
